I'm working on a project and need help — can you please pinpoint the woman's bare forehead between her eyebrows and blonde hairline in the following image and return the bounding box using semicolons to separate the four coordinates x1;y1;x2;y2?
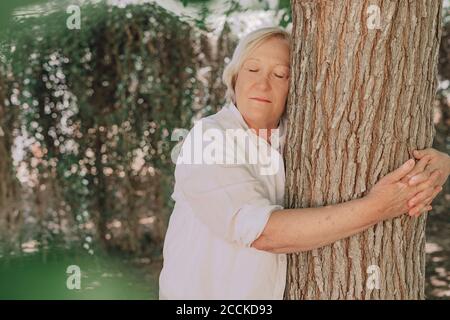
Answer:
243;38;290;67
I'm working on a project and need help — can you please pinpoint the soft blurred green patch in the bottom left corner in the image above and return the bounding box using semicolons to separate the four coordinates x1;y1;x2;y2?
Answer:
0;245;158;300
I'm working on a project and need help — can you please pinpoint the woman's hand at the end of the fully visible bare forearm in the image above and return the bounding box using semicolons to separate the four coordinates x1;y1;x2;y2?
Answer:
367;159;441;220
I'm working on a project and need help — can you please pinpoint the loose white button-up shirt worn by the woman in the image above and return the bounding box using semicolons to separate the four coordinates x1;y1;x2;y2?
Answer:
159;103;287;300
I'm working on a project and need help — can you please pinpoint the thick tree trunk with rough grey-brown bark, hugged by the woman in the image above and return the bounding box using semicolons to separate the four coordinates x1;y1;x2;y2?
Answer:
285;0;442;299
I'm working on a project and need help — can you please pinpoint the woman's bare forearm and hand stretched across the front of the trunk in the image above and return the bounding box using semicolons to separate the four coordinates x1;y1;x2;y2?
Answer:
251;159;440;253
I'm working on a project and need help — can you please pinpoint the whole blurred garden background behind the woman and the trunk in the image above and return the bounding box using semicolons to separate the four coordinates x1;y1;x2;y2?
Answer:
0;0;450;299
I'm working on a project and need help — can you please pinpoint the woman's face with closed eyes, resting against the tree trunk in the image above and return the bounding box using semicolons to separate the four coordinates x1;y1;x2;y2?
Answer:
234;37;290;129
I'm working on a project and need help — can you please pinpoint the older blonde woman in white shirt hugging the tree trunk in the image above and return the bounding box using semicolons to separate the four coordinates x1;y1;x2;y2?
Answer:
159;27;450;299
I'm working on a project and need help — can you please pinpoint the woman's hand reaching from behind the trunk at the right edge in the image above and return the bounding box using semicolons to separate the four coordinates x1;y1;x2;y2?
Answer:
408;148;450;216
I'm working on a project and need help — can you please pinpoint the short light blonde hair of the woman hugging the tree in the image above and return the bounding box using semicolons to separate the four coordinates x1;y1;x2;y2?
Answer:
222;27;291;103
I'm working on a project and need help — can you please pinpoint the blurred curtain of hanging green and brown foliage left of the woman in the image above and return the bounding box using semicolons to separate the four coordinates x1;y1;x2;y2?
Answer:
0;0;290;254
